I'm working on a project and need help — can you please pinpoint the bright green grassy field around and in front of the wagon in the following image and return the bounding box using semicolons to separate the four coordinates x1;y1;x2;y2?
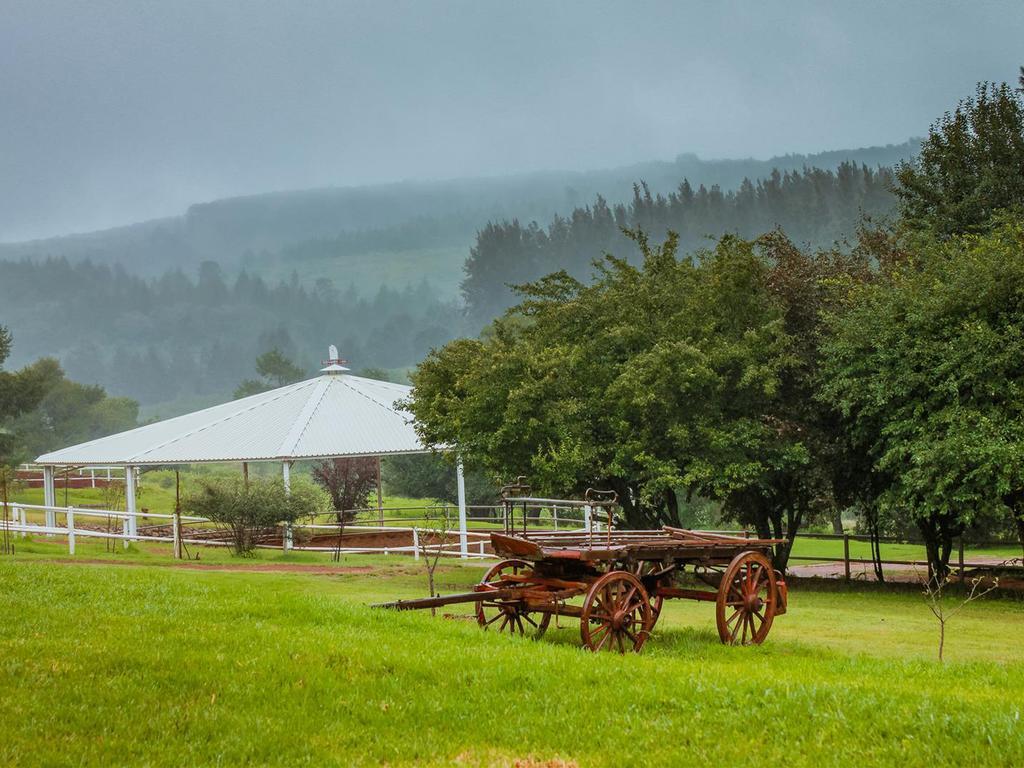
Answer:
0;543;1024;766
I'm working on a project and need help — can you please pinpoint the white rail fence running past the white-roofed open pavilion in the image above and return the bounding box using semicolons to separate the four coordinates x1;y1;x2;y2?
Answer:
0;503;494;559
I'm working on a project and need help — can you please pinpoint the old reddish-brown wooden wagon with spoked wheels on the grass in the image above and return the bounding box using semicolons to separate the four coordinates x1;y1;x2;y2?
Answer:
382;490;786;653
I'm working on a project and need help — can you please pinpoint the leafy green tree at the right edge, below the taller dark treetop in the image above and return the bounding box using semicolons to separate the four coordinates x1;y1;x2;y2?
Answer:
822;219;1024;574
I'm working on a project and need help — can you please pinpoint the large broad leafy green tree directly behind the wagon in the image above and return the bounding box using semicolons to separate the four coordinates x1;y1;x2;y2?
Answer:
409;231;835;566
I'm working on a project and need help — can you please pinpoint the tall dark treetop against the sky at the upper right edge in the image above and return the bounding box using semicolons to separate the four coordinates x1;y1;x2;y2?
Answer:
895;83;1024;238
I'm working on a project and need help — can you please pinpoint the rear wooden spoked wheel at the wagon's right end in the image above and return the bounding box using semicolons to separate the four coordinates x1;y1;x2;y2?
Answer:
716;552;778;645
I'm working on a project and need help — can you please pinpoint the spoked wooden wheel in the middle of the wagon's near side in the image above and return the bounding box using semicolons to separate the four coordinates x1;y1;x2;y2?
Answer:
580;570;654;653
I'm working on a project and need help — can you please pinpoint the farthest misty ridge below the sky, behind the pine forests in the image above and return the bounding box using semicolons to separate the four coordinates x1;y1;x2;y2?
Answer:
0;140;920;295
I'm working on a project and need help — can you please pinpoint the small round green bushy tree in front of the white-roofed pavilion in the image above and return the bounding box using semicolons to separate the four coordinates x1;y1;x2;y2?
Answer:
187;476;329;556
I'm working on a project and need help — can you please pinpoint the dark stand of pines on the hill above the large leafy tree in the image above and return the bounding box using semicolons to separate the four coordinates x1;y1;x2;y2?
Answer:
462;163;895;323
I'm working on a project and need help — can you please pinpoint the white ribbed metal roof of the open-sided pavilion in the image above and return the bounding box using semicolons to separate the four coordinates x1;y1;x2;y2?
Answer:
36;372;426;466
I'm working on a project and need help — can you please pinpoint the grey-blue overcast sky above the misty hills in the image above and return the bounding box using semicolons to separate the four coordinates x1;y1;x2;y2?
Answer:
0;0;1024;241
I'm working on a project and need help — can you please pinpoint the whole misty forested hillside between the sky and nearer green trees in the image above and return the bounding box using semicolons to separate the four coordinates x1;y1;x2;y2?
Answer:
0;143;912;416
